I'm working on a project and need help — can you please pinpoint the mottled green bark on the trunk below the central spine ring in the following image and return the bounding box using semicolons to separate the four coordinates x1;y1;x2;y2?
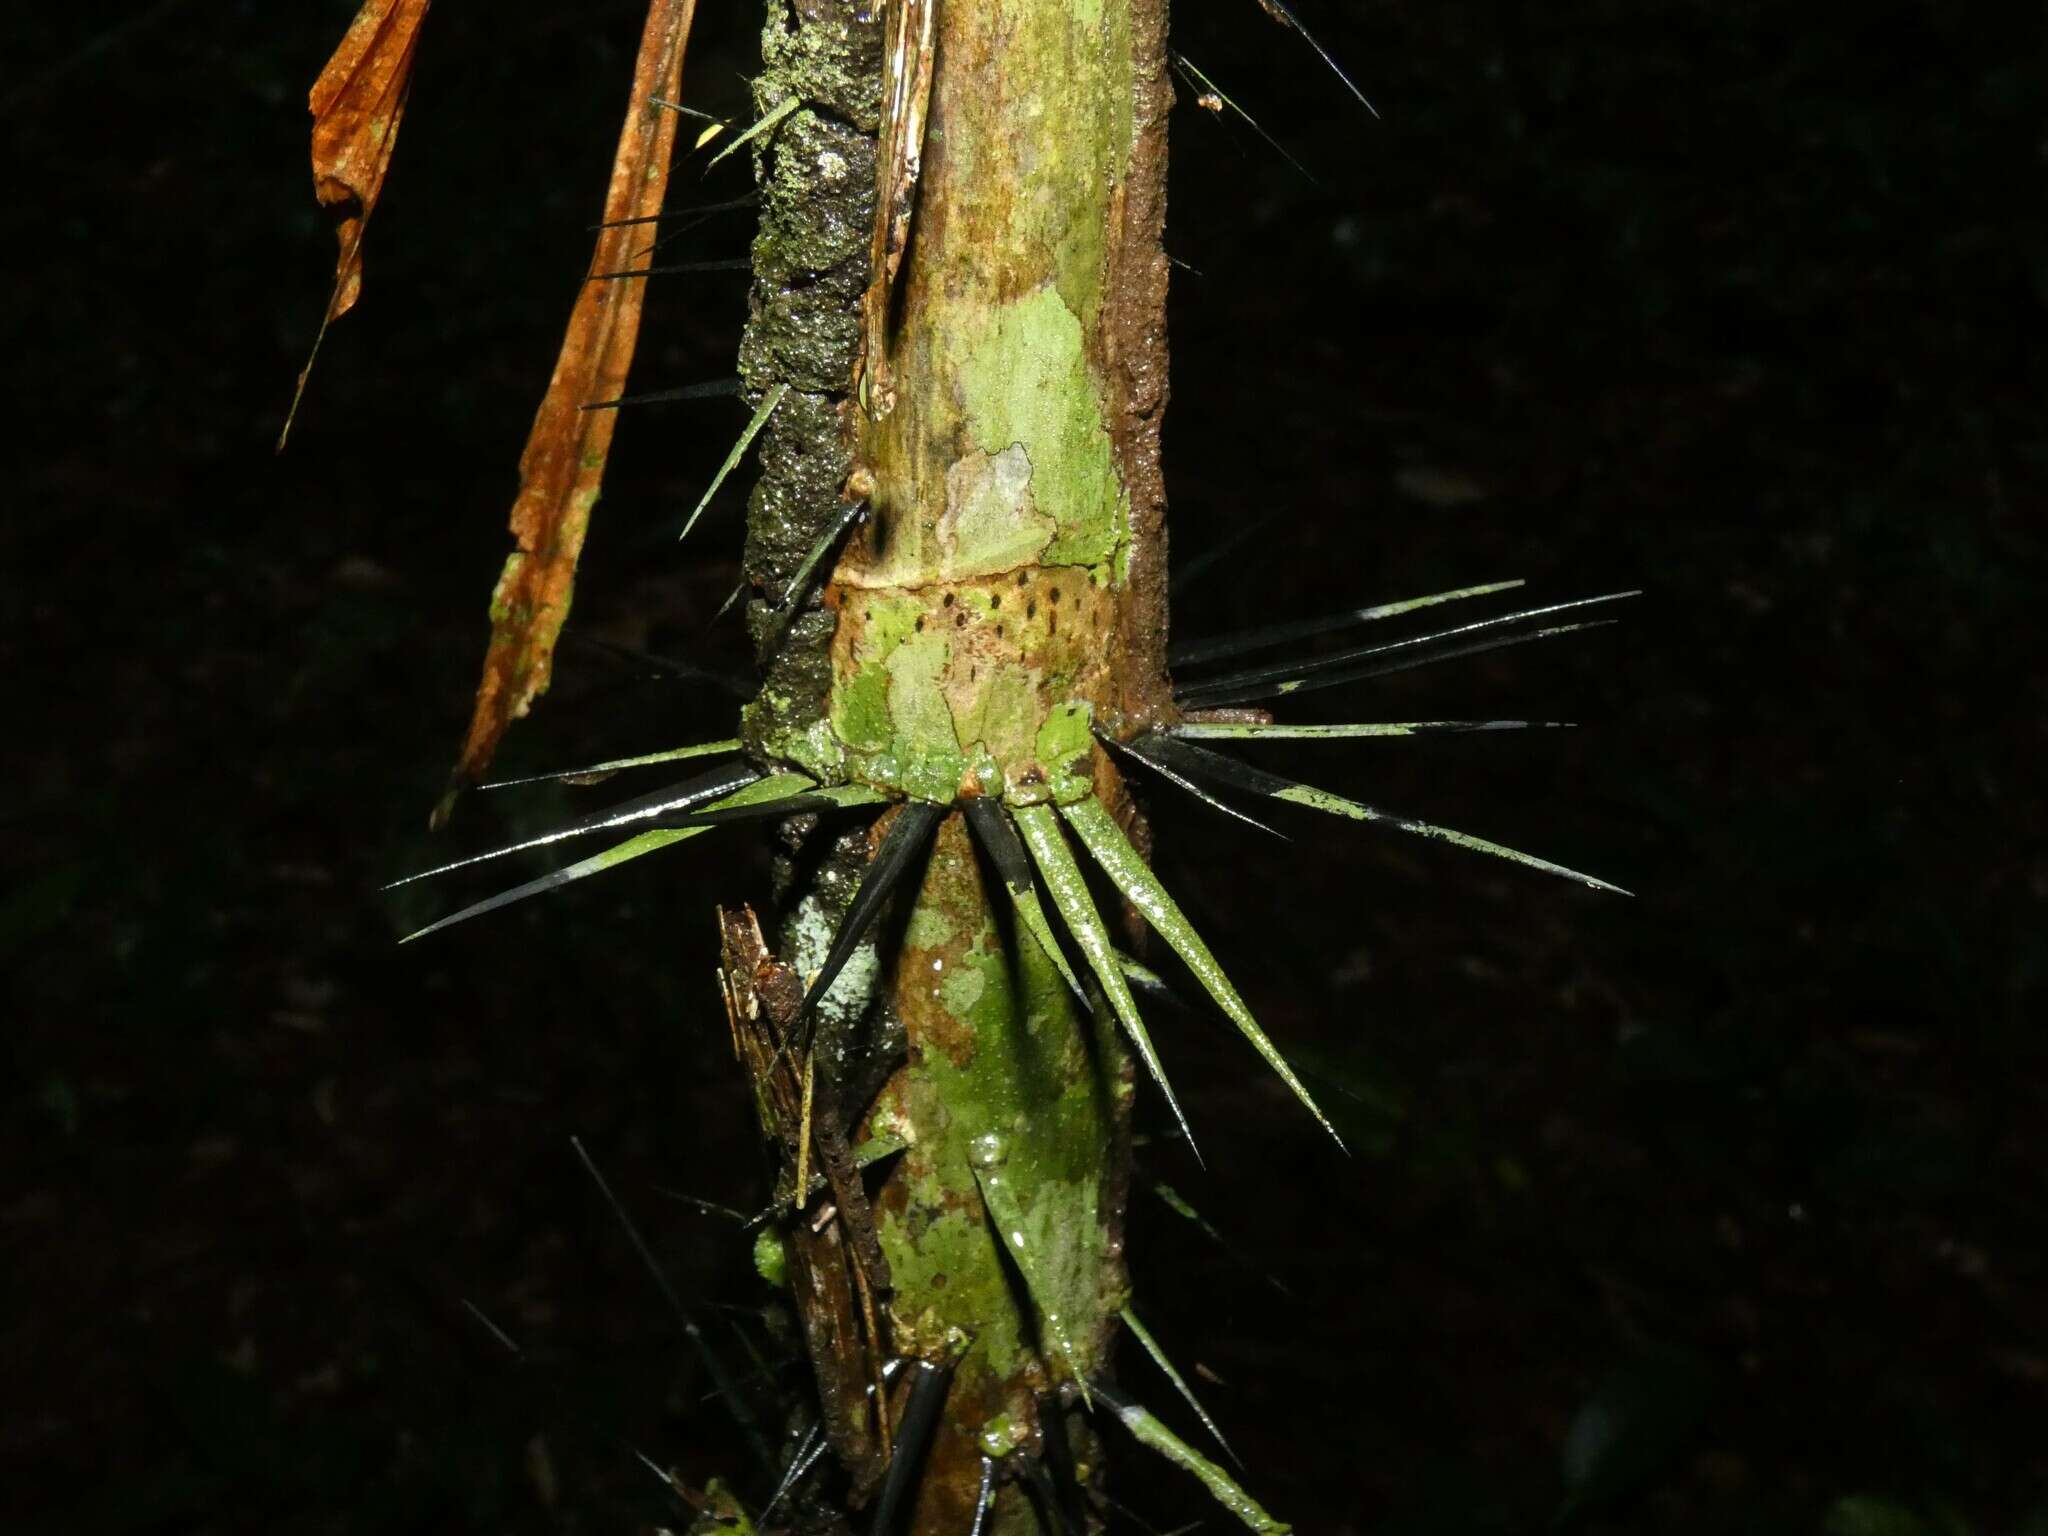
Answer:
870;815;1130;1532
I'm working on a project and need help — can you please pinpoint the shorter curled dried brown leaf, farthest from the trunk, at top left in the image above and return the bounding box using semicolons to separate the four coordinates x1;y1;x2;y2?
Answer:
276;0;432;449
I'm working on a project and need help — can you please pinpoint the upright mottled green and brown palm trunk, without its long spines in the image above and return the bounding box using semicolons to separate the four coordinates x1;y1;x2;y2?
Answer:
745;0;1169;1536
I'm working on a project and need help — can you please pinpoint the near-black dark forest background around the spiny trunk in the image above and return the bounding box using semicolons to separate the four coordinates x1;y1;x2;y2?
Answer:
0;0;2048;1536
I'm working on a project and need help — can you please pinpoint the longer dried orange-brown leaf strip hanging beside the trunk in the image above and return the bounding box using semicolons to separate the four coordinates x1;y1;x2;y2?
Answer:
434;0;696;825
